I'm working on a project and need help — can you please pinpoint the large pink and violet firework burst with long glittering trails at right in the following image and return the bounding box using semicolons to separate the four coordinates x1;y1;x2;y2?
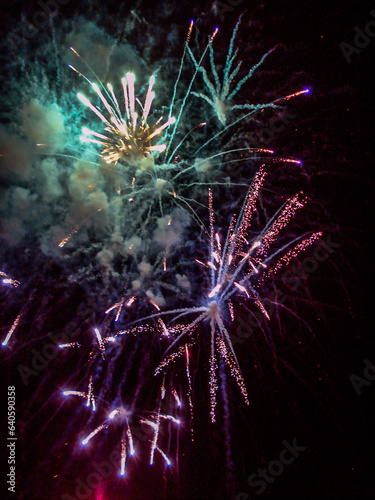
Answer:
114;166;320;422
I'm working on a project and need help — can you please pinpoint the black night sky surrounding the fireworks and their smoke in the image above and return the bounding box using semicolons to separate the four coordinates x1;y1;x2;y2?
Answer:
0;0;375;500
